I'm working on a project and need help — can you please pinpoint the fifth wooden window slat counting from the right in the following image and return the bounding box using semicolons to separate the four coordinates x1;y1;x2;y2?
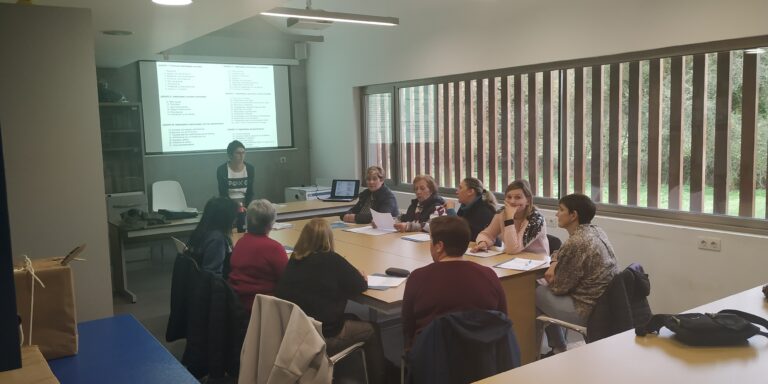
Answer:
647;59;664;208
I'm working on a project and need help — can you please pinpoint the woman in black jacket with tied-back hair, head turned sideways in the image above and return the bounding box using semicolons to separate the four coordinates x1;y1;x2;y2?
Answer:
445;177;496;239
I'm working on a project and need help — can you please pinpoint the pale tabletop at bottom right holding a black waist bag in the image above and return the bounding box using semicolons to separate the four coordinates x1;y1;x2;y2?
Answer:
478;286;768;384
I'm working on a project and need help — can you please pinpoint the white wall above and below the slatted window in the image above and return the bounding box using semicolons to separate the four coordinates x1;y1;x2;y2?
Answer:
308;0;768;312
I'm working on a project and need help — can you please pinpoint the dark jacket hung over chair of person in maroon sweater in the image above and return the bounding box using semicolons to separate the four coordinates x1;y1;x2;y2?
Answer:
406;310;520;384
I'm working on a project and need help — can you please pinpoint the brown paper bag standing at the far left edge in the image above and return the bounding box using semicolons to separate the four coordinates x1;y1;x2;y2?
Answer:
13;258;77;359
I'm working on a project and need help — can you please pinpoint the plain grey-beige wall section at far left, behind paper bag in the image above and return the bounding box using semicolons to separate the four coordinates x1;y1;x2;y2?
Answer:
0;4;112;321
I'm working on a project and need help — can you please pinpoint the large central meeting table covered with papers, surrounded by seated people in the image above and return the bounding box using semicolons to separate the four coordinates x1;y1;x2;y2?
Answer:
255;218;547;364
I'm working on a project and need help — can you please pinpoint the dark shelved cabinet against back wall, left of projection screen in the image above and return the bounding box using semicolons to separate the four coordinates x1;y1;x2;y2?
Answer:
99;103;145;194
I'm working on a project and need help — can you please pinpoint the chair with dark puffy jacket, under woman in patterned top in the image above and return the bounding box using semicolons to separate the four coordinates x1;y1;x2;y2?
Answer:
536;263;651;343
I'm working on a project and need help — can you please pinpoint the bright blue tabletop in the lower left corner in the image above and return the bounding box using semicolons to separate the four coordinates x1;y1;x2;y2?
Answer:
48;314;199;384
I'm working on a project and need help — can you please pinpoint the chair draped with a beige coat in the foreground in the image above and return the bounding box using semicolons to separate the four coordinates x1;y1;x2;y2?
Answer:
238;295;368;384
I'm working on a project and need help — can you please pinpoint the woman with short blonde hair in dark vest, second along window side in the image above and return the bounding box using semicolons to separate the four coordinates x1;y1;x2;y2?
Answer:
395;175;445;232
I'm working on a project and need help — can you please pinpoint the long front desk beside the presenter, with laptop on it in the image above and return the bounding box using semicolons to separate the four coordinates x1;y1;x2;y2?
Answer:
109;200;354;303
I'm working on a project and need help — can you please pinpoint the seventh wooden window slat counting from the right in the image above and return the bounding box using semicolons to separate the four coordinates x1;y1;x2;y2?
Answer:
608;63;624;204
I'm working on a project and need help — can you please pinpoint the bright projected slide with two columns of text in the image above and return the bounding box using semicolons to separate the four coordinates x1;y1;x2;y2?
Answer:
156;62;278;152
